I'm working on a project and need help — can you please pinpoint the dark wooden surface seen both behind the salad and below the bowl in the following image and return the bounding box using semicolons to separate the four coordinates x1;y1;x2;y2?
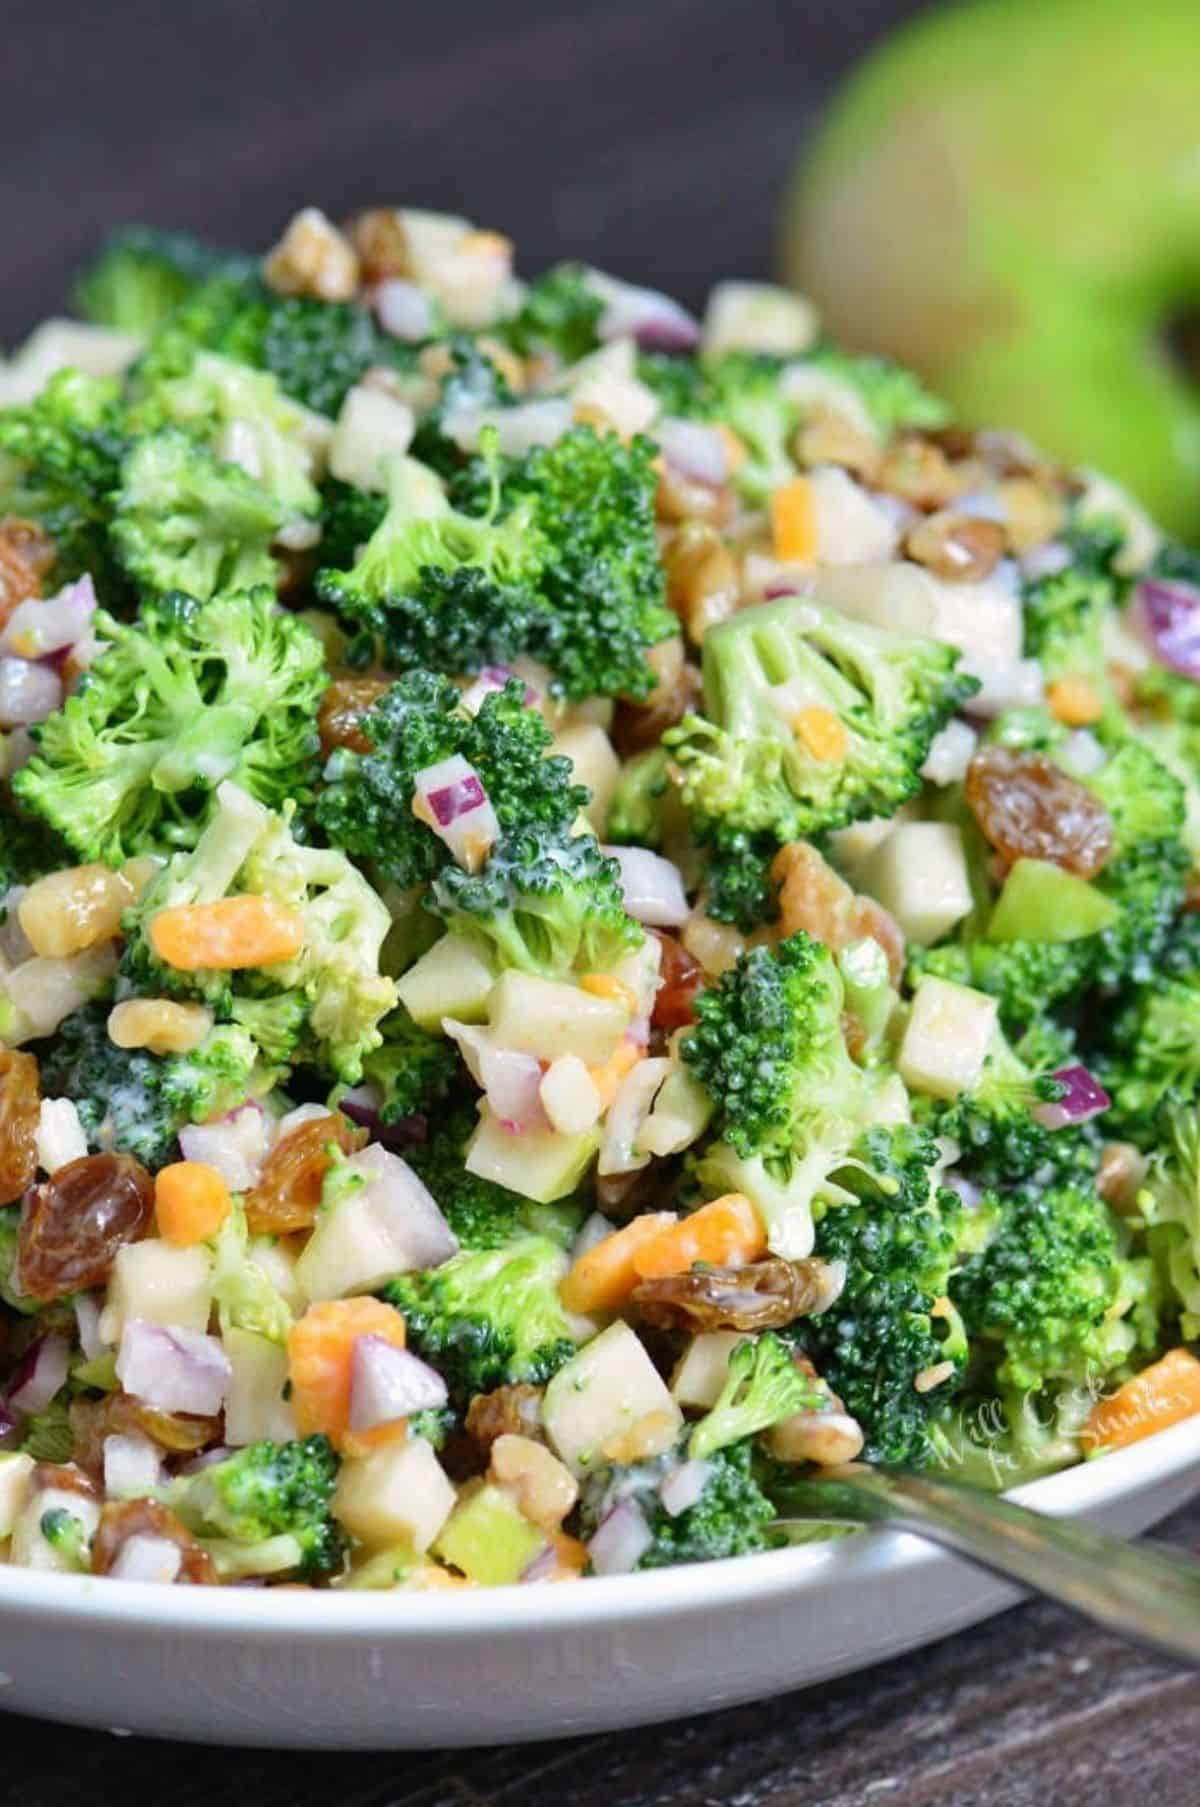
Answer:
0;0;1200;1785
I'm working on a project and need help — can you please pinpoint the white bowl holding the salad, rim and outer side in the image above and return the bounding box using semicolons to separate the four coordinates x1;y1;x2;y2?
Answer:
0;1418;1200;1749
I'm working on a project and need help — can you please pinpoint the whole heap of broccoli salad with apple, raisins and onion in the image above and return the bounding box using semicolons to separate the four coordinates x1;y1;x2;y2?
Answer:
0;208;1200;1590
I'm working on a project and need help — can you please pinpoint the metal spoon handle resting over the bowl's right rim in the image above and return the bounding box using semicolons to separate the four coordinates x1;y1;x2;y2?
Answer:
786;1467;1200;1662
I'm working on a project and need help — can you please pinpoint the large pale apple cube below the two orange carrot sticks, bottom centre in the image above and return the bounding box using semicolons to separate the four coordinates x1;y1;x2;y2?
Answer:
542;1323;683;1475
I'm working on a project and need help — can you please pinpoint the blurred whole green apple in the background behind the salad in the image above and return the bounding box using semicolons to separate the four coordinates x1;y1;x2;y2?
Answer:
783;0;1200;535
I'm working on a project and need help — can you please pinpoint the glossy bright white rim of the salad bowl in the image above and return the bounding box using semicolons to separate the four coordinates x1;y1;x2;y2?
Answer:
0;1417;1200;1641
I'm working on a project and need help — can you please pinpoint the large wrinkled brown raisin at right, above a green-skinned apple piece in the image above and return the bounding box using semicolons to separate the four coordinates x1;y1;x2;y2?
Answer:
965;746;1113;878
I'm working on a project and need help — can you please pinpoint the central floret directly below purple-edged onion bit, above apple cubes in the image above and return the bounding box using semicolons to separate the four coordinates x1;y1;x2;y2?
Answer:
428;826;643;978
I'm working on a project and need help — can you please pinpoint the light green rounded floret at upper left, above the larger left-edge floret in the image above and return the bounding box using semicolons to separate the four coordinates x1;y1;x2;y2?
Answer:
112;428;287;602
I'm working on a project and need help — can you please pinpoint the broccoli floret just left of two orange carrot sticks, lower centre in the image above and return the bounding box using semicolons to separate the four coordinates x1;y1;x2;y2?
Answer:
383;1236;575;1406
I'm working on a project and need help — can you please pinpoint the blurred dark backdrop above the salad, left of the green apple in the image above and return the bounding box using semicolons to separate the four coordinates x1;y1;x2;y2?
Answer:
0;0;914;345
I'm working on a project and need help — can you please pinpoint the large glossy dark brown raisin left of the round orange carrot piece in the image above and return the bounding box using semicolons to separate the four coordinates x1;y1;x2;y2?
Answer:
16;1155;154;1301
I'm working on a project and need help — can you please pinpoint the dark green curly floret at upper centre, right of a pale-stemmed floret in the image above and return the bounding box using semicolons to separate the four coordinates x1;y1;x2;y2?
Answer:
452;426;680;701
